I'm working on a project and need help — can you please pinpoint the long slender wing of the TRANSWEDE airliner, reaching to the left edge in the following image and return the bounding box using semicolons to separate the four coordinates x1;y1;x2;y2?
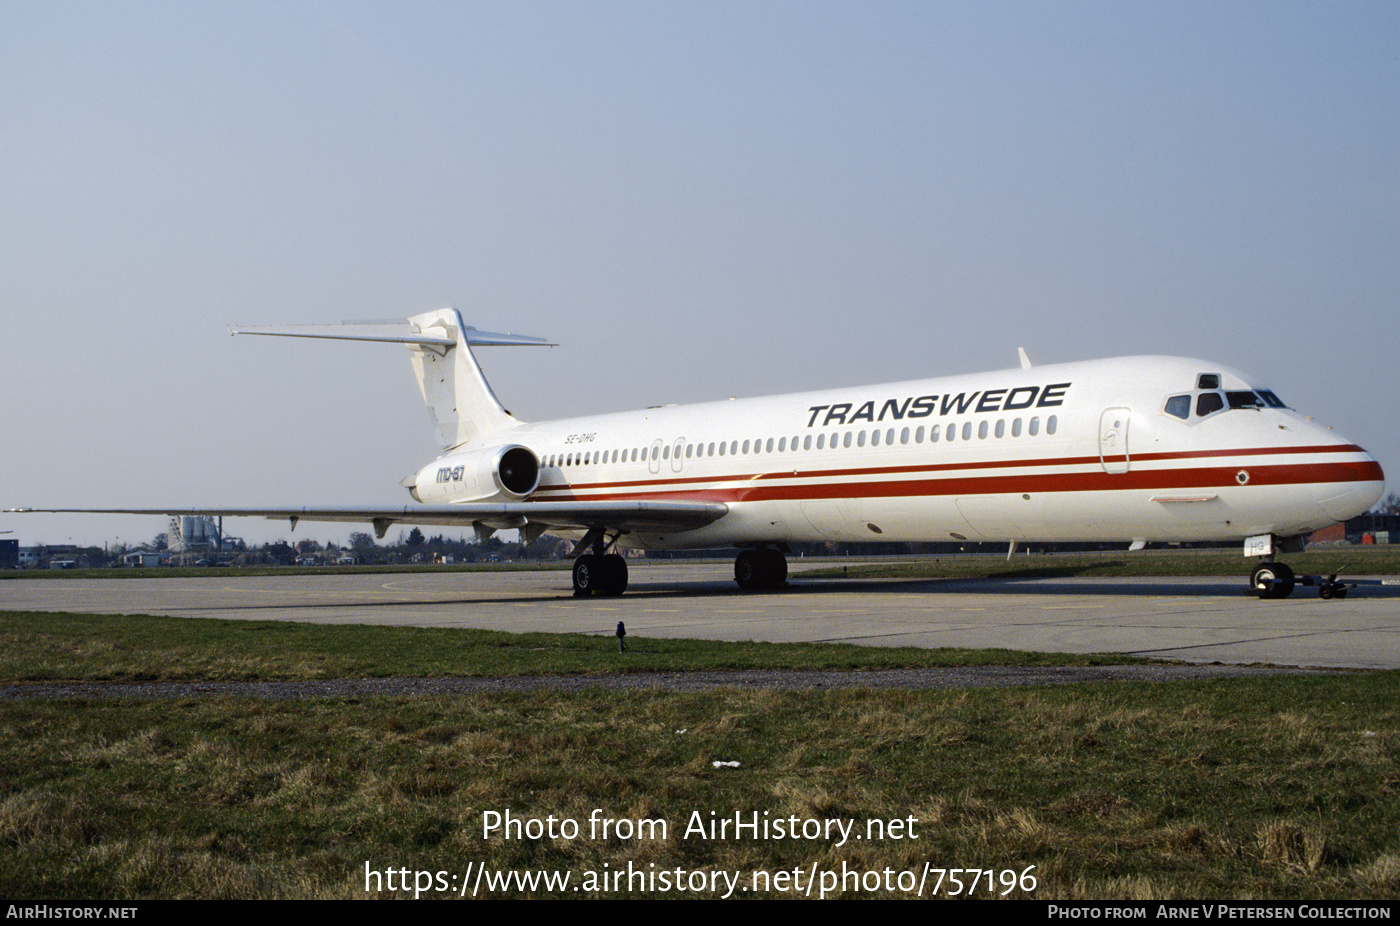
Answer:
6;500;729;539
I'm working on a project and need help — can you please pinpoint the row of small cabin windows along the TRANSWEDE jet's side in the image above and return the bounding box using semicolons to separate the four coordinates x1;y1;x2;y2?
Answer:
545;415;1060;468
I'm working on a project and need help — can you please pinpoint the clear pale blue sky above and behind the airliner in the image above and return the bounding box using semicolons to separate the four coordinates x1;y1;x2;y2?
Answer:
0;0;1400;545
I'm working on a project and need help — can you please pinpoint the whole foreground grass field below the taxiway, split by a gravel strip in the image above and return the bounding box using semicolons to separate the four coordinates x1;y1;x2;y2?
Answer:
0;614;1400;899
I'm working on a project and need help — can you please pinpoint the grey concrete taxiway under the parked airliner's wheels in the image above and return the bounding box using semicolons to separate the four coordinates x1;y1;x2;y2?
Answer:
0;562;1400;668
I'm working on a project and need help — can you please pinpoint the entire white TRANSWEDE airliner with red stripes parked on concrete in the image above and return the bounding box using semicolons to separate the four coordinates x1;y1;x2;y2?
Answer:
13;308;1385;598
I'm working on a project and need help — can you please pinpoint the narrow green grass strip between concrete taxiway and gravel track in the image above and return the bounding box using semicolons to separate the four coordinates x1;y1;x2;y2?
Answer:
0;611;1144;682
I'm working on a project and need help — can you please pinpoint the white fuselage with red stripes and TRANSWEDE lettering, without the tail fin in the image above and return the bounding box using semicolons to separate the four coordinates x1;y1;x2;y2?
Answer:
414;357;1383;548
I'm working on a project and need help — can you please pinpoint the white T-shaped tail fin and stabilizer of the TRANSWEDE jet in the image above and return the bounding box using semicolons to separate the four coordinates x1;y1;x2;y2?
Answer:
228;308;554;450
